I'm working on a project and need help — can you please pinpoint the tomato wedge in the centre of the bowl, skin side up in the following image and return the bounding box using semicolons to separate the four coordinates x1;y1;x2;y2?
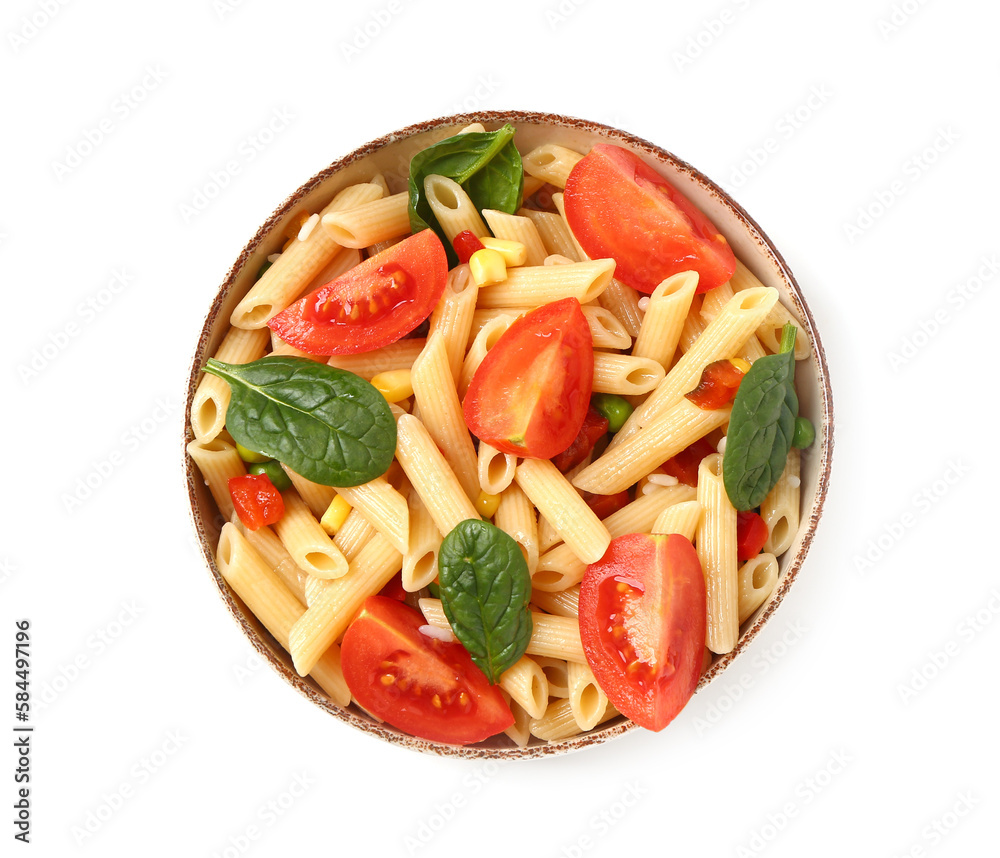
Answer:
463;298;594;459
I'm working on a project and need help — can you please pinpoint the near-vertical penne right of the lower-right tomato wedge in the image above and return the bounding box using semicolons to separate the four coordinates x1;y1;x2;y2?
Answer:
695;453;740;654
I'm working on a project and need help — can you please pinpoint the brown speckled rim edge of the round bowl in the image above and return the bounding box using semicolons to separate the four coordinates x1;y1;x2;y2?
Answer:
183;110;834;760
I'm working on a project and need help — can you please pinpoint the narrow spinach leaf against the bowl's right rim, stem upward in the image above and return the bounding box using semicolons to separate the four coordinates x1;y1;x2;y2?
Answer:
722;325;799;510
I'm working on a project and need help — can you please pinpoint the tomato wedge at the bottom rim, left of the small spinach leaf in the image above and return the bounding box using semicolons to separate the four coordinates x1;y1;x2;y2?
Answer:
340;596;514;745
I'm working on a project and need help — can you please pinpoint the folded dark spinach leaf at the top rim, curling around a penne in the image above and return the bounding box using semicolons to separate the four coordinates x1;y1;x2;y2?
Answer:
409;124;524;266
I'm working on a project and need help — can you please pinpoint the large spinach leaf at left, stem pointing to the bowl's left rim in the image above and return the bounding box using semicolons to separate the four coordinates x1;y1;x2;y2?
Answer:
205;356;396;486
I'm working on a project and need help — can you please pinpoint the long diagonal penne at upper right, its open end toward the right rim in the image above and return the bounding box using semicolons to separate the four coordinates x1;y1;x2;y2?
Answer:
608;288;778;448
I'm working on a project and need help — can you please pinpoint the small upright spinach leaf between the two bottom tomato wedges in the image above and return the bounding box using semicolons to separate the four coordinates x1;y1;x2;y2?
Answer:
438;518;531;685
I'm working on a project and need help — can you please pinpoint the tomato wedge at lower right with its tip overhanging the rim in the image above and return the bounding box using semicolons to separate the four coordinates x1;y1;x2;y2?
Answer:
580;533;706;730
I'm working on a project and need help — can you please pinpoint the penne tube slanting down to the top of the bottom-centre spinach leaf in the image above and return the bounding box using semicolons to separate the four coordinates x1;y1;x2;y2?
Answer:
396;414;480;535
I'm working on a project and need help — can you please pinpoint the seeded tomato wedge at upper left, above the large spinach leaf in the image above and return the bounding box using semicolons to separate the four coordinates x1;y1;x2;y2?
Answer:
267;229;448;355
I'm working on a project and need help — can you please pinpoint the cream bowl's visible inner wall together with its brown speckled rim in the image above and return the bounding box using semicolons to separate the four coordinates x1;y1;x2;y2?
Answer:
184;111;833;759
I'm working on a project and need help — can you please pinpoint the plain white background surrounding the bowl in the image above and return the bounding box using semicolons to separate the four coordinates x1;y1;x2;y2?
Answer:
0;0;1000;858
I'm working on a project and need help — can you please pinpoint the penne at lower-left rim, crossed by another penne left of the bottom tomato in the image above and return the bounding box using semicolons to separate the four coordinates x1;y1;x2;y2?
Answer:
216;523;351;706
